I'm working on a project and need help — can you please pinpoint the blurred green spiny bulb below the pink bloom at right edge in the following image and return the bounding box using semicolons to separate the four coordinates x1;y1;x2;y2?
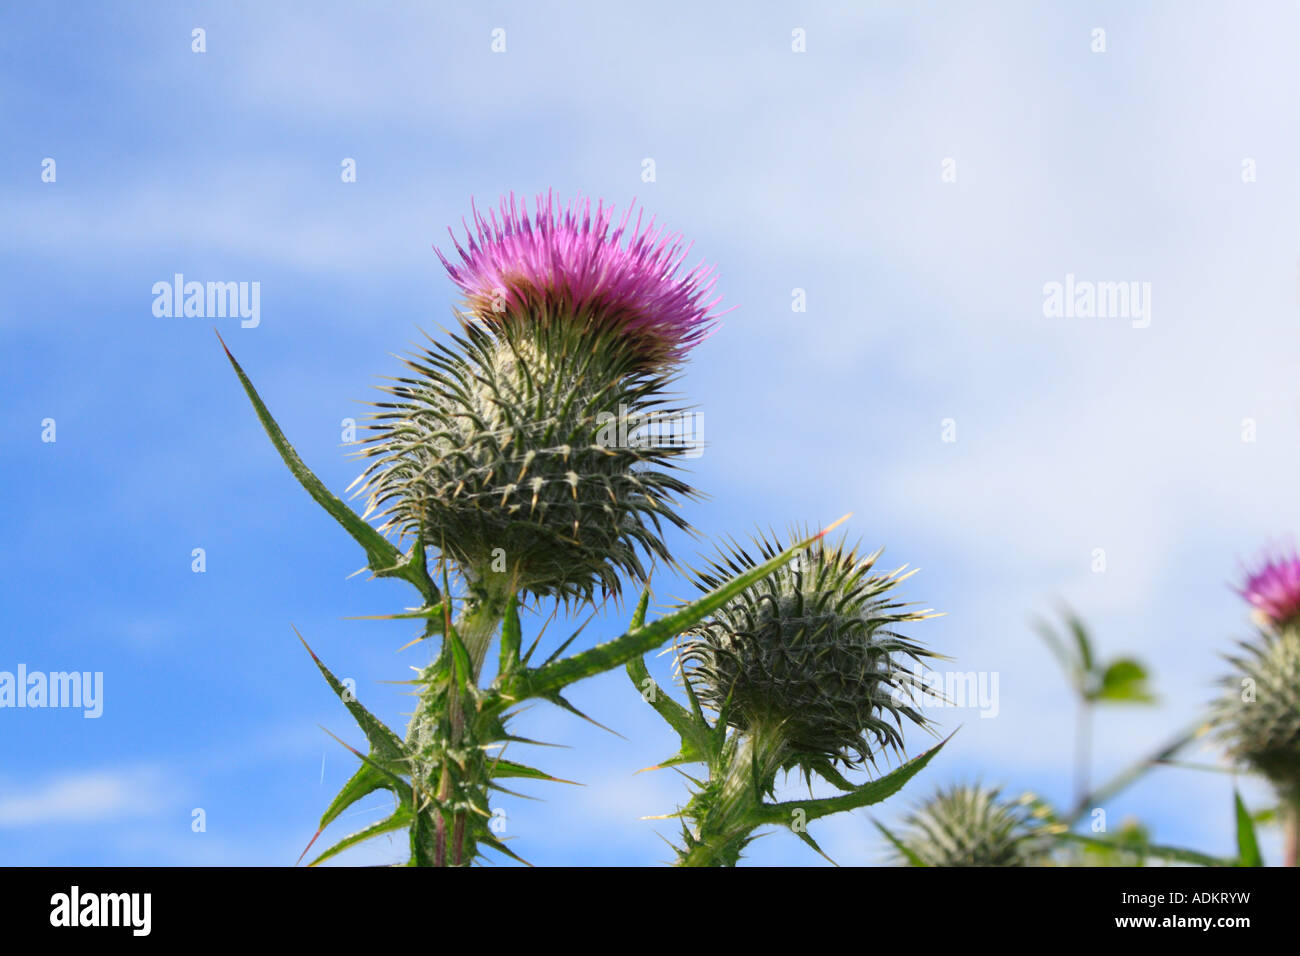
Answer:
1216;623;1300;801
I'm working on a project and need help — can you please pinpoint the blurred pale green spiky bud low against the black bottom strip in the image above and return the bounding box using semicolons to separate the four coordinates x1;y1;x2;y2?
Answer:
896;784;1043;866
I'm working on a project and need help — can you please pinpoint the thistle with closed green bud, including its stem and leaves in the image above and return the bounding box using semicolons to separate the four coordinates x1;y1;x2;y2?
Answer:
628;533;943;866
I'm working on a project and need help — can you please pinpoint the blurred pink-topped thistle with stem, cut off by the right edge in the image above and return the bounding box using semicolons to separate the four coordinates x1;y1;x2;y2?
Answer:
1216;554;1300;866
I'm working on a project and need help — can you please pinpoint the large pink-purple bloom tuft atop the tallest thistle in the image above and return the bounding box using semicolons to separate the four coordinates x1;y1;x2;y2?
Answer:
434;191;720;364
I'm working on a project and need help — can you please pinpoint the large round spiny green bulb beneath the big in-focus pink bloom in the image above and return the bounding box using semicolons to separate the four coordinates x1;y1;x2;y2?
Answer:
359;319;694;600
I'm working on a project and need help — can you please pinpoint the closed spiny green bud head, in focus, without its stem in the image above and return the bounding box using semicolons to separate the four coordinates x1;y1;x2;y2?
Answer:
679;531;935;773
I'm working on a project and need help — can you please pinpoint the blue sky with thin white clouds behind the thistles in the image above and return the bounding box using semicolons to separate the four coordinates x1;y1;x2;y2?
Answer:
0;3;1300;865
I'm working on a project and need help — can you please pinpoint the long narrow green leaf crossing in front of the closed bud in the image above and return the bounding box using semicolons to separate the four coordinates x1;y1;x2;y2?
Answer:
522;518;844;698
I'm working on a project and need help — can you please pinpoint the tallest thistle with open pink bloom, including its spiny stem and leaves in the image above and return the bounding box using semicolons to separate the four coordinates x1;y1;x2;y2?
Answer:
226;194;946;866
